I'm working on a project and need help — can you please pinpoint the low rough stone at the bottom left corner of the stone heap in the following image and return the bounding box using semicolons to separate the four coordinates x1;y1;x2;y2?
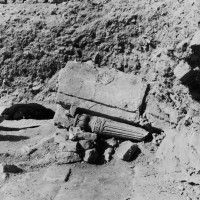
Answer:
56;152;81;164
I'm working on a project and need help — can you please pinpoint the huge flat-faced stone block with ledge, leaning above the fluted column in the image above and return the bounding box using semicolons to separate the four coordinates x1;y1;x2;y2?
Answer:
57;62;148;122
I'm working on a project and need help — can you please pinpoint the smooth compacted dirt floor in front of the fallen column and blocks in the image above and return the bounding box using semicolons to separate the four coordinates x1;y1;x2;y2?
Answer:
0;108;193;200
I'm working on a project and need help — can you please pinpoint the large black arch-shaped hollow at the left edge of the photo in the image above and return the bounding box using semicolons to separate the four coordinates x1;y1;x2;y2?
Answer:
1;103;55;120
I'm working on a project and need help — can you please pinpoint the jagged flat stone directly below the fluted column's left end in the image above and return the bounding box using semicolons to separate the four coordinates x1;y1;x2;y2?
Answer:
69;127;97;141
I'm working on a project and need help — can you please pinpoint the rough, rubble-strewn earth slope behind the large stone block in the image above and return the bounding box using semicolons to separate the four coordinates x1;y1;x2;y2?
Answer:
0;0;199;177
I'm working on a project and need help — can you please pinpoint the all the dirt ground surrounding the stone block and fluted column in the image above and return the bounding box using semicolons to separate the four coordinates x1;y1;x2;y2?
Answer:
0;0;200;200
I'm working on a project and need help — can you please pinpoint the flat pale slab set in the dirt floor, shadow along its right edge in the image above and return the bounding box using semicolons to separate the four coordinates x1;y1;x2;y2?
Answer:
43;165;71;182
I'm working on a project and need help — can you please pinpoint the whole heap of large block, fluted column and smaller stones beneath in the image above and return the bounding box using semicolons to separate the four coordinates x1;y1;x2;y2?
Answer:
54;62;148;164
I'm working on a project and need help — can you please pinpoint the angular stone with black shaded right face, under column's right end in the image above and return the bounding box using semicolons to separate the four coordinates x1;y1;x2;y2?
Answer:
116;141;138;161
